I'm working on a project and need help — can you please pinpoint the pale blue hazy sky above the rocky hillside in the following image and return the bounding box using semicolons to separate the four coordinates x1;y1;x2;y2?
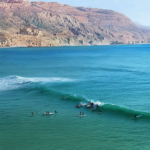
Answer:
35;0;150;26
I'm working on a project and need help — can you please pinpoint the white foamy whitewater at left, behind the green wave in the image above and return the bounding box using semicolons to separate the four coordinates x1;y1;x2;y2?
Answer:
0;76;75;91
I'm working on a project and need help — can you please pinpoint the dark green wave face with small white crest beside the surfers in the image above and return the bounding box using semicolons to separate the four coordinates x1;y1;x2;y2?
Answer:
19;82;150;118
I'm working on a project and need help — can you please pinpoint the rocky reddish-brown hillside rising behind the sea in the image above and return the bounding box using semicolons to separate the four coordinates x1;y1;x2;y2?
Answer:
0;0;150;46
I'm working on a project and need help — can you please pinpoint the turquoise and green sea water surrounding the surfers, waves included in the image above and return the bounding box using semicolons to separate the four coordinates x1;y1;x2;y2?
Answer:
0;45;150;150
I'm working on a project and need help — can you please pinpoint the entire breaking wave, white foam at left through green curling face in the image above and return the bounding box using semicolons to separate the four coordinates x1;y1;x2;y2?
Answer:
0;76;150;118
